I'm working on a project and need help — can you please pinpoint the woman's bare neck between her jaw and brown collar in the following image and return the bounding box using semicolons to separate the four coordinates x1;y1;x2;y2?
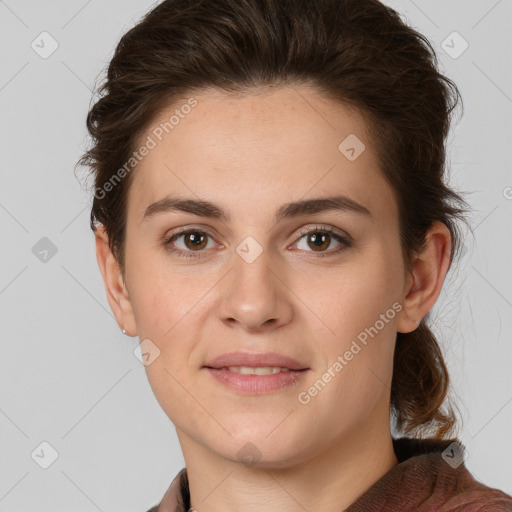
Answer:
177;423;398;512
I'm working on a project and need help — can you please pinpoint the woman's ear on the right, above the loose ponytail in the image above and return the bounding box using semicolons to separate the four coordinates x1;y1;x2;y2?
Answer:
397;221;452;333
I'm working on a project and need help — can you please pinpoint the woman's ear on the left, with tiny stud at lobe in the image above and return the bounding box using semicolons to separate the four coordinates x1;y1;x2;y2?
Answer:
94;224;137;336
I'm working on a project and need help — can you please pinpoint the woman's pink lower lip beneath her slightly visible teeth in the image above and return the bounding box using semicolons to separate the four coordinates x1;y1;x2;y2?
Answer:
205;368;307;395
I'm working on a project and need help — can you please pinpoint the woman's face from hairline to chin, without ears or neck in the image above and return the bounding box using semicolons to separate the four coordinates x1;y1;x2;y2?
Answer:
110;86;414;467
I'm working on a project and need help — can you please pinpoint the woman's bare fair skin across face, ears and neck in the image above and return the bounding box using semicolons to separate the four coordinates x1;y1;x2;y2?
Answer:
96;85;451;512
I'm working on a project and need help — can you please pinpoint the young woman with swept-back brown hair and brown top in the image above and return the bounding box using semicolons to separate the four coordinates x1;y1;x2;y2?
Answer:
81;0;512;512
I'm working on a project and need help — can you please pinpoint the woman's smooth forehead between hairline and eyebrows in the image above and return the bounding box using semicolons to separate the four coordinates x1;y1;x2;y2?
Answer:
128;86;393;225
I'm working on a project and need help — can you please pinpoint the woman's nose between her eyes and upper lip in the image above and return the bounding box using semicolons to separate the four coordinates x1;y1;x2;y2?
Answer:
220;244;293;331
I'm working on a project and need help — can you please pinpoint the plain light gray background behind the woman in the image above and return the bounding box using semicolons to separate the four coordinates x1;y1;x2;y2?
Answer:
0;0;512;512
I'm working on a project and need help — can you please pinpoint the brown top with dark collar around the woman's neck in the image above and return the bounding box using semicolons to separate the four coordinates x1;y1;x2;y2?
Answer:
148;437;512;512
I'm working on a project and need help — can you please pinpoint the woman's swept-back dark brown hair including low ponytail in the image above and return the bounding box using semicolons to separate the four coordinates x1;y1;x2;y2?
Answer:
78;0;467;438
